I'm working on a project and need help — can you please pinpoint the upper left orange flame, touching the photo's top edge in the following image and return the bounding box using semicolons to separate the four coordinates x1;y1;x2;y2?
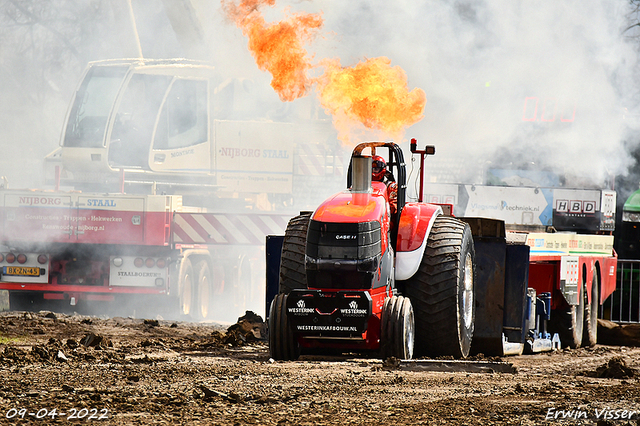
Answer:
223;0;323;101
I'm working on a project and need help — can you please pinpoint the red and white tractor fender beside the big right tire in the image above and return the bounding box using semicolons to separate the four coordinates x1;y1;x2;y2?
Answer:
395;203;442;281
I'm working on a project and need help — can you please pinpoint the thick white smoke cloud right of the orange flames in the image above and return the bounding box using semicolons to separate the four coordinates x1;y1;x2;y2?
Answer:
246;0;638;185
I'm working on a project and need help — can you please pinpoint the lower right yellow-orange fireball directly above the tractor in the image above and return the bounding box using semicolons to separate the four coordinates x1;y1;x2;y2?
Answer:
317;57;427;140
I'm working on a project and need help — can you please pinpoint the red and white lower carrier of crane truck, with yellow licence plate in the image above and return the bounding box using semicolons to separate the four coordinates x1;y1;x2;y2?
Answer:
0;190;288;319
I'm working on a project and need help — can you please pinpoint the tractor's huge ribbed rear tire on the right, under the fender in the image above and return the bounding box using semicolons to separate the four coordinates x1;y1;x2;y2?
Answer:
404;216;475;358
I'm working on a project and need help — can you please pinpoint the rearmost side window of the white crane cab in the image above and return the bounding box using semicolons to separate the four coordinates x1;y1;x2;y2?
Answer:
153;79;208;150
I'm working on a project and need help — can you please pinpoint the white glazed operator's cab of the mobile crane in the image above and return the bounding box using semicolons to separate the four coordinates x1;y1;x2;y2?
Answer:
53;60;217;183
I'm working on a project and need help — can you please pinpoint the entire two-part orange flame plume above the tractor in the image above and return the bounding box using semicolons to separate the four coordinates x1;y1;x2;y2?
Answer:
221;0;427;141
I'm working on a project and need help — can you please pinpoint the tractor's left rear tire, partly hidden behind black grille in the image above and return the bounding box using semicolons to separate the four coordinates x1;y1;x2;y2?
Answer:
280;213;311;293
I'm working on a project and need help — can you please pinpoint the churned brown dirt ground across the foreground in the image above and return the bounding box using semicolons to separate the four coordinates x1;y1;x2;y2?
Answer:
0;311;640;425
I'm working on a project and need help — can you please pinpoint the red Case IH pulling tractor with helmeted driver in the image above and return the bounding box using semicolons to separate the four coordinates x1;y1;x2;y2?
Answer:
269;141;476;360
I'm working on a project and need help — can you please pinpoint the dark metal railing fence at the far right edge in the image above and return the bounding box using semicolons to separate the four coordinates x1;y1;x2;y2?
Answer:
599;260;640;323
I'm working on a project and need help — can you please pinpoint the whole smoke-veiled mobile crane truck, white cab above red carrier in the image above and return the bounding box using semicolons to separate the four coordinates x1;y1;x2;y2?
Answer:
0;59;344;320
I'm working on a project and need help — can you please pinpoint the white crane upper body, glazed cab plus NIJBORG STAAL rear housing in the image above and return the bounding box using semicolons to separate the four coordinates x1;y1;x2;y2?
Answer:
45;59;345;210
